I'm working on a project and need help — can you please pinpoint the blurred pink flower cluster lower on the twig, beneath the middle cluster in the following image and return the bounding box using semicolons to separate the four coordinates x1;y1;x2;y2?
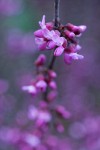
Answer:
28;100;71;134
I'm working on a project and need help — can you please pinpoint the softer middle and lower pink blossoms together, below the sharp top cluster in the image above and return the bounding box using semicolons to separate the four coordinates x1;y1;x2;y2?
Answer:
22;54;71;141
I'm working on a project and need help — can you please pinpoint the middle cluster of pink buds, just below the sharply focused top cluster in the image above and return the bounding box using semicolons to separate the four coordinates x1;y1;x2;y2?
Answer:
22;54;57;97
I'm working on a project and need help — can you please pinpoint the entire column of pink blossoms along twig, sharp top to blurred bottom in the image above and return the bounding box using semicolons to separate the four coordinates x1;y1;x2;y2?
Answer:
22;12;86;150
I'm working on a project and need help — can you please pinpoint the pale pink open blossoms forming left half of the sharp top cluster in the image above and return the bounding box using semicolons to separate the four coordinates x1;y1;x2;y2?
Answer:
34;16;66;55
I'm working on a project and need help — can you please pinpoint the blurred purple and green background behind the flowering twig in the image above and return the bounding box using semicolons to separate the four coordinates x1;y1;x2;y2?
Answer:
0;0;100;150
